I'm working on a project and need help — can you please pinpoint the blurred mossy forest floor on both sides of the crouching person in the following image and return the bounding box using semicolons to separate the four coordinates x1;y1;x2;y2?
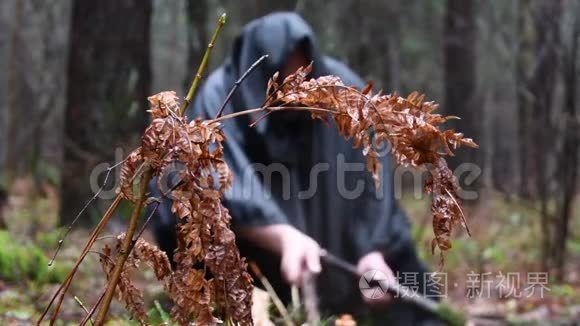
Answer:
0;180;580;325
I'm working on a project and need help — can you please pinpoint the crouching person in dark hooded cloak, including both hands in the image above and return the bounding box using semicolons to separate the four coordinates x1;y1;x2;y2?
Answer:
153;13;442;325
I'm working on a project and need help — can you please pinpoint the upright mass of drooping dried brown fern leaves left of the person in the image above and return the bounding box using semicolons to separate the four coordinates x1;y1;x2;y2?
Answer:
120;92;252;325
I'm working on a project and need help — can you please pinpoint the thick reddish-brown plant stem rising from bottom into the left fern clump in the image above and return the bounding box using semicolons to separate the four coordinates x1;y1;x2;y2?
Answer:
95;165;153;325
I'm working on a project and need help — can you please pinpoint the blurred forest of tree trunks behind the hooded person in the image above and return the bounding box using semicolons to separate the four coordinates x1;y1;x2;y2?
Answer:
0;0;580;324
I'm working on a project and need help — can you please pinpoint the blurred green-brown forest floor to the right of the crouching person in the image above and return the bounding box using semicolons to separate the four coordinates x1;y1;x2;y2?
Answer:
402;193;580;325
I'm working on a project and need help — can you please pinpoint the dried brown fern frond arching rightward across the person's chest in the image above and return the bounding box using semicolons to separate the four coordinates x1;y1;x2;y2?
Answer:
265;65;478;258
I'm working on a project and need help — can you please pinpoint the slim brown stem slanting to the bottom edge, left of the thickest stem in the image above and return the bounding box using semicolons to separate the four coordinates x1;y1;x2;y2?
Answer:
37;196;123;325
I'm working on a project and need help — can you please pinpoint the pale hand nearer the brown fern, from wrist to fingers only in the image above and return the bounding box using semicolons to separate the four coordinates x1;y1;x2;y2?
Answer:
280;227;321;286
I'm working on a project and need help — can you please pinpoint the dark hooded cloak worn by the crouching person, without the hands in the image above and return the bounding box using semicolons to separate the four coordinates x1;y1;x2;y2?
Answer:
156;13;410;305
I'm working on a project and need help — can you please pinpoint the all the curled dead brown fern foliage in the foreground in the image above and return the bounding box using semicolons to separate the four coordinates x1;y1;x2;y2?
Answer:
102;66;477;325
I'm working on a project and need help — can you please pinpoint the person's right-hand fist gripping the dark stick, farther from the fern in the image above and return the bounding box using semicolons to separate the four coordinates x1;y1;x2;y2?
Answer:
357;251;397;305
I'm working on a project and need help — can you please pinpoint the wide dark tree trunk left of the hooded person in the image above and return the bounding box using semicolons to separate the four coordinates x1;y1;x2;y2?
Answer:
61;0;152;223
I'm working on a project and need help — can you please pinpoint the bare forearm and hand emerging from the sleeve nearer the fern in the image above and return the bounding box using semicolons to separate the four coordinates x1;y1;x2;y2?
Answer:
237;224;321;286
